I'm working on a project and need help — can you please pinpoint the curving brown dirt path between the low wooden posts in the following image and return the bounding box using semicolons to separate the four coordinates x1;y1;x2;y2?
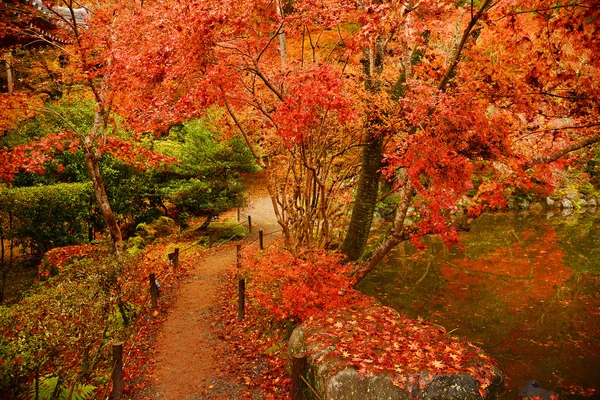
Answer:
154;189;279;400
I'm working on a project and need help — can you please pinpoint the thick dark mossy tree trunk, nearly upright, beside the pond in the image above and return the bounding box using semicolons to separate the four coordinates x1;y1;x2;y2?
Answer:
341;135;383;261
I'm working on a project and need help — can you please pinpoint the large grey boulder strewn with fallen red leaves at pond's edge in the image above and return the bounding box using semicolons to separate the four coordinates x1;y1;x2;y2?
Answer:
288;304;504;400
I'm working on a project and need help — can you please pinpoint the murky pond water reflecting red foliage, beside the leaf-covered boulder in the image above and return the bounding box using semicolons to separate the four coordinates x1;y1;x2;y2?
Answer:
359;212;600;400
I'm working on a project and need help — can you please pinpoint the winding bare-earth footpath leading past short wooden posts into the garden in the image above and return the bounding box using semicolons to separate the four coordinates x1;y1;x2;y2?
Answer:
133;177;280;400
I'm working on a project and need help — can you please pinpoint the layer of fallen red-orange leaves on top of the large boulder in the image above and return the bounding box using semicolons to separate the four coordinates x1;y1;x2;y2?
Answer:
303;304;497;396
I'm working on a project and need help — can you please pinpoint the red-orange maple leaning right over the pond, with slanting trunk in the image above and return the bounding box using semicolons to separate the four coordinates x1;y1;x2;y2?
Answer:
362;2;600;280
